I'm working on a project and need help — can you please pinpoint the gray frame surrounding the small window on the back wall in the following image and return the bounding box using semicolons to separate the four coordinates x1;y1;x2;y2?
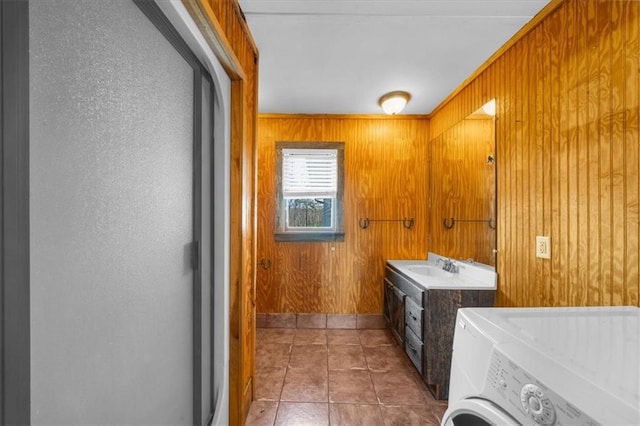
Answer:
274;141;344;242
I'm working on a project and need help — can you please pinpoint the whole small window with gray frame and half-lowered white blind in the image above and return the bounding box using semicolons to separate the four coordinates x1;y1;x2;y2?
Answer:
275;142;344;241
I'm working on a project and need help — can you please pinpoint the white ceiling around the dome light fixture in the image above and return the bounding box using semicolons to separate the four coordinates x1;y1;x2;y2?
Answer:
239;0;549;114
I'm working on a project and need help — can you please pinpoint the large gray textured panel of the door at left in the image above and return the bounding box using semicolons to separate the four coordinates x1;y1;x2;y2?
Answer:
29;0;198;424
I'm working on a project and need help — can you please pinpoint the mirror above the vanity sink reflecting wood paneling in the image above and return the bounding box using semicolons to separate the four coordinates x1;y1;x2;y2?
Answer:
429;118;496;265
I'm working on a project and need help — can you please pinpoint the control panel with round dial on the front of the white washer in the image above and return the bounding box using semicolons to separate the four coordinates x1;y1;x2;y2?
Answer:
483;348;599;426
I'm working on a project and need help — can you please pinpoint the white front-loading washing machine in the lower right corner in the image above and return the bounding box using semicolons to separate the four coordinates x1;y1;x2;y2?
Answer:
442;307;640;426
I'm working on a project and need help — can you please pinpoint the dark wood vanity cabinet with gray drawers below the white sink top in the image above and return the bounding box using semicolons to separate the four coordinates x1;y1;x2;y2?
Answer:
384;265;495;399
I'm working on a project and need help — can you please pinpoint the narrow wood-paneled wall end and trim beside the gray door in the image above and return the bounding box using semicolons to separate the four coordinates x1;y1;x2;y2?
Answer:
183;0;258;424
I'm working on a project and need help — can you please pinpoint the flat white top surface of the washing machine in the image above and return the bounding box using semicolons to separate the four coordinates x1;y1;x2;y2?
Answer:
462;307;640;420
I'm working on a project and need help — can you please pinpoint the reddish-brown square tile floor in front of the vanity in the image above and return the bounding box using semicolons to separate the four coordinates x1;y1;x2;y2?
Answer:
246;328;447;426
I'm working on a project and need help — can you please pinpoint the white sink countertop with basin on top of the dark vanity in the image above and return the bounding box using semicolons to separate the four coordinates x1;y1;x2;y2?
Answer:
387;253;497;290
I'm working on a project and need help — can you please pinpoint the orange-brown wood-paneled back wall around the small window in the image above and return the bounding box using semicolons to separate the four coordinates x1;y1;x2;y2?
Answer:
256;115;429;314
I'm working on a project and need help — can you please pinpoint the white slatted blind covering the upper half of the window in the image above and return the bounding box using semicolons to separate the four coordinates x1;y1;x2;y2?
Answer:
282;149;338;198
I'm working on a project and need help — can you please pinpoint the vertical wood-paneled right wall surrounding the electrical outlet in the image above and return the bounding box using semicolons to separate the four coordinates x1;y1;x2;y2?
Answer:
431;0;640;306
